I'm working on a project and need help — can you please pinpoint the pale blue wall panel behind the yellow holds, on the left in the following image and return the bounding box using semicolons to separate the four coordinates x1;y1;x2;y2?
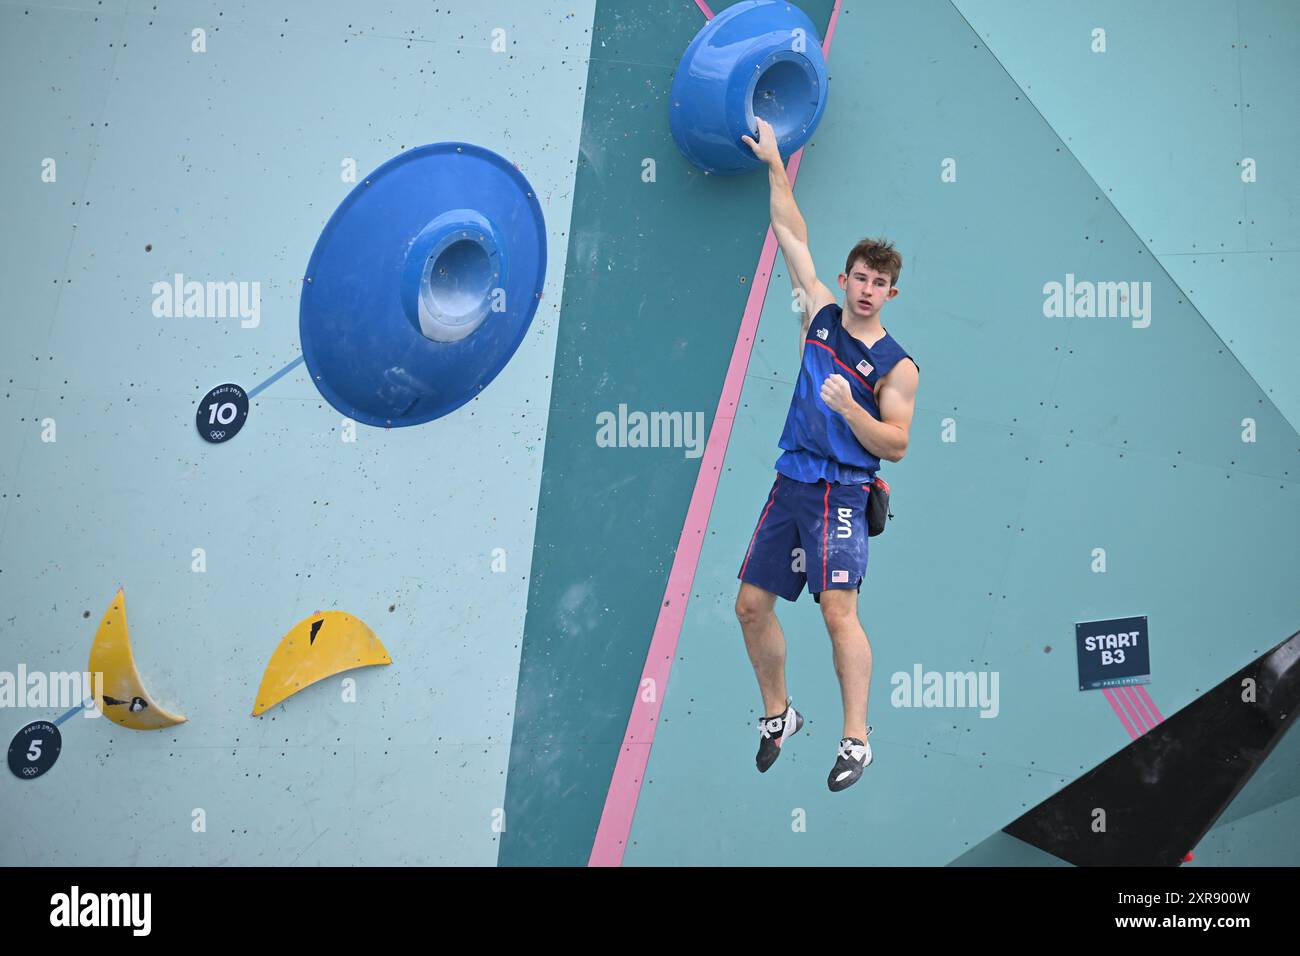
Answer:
0;0;594;865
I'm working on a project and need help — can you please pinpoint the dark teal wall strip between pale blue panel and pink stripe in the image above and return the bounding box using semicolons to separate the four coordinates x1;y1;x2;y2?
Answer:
501;0;831;865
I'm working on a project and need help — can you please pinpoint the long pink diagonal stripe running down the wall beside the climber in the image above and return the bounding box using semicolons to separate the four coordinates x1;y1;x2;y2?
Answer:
588;0;842;866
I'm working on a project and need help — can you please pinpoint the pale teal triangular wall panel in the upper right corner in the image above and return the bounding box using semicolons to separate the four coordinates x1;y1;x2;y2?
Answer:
954;0;1300;428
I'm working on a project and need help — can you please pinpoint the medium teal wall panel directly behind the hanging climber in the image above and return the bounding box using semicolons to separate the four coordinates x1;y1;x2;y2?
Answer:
625;3;1300;865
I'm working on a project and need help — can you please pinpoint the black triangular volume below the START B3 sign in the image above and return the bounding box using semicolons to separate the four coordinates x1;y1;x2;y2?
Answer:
1004;631;1300;866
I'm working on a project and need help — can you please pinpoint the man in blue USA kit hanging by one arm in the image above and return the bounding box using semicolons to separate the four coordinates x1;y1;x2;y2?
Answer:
736;120;920;791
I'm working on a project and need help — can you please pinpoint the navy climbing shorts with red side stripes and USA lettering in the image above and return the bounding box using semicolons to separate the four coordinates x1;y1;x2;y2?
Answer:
737;473;867;601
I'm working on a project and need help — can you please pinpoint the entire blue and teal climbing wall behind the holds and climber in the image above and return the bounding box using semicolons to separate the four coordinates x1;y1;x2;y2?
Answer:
0;0;1300;865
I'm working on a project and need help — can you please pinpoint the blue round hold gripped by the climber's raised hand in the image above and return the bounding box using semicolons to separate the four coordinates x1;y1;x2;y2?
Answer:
668;0;827;176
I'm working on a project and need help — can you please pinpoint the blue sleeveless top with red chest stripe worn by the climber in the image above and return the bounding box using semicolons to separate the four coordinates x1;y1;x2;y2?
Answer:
776;302;920;485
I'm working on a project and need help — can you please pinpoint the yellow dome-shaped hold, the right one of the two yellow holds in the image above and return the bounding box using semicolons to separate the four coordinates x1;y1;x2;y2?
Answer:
252;611;393;717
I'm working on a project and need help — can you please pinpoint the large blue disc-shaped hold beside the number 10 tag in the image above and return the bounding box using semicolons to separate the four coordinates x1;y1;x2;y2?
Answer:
299;143;546;427
